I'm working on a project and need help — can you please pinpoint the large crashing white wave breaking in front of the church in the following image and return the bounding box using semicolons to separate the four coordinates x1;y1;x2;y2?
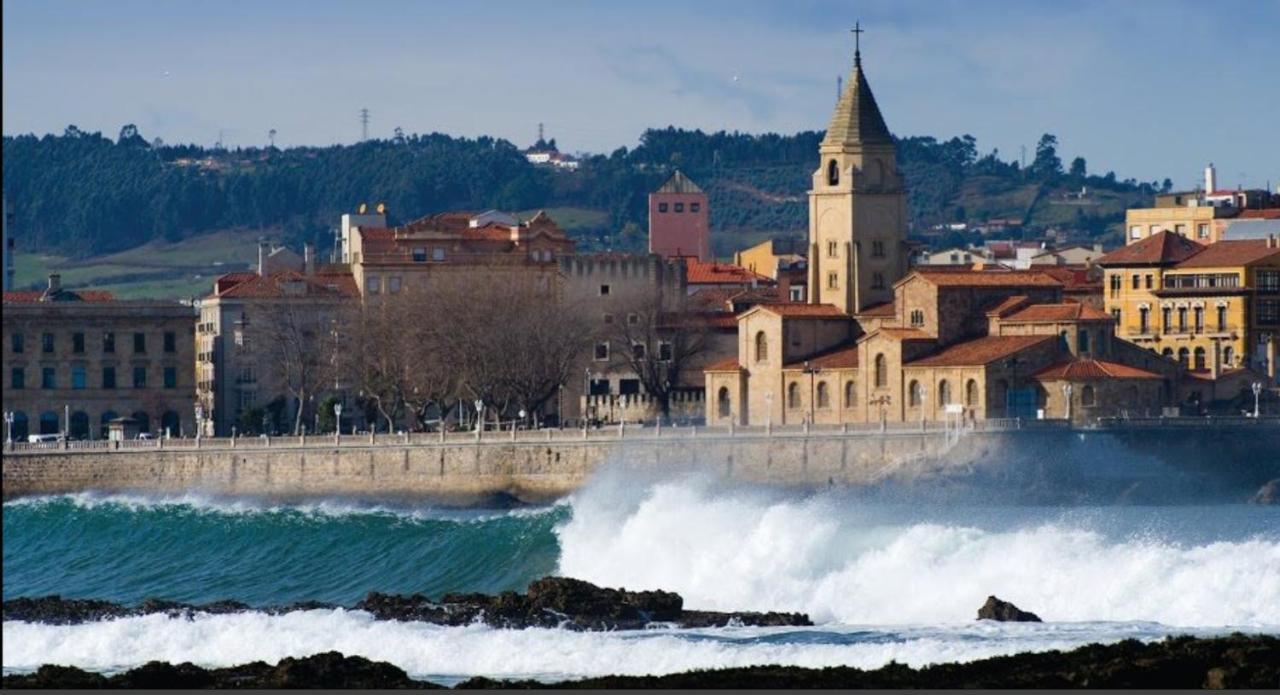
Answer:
557;479;1280;627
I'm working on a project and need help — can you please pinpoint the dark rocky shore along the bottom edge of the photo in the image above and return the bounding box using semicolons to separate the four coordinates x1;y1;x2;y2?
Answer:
4;634;1280;690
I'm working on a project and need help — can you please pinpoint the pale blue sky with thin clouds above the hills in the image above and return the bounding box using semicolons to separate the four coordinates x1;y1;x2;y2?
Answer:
3;0;1280;188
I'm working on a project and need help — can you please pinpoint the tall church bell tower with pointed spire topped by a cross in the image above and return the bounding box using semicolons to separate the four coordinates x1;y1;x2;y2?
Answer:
809;27;908;314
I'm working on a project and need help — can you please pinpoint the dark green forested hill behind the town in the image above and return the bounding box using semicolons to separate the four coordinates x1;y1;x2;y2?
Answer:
4;125;1155;257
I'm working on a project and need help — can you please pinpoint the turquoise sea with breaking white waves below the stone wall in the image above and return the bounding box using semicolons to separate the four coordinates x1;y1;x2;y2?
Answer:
3;466;1280;685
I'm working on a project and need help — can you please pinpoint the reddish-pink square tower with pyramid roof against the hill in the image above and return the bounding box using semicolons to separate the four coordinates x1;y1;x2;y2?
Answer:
649;170;712;261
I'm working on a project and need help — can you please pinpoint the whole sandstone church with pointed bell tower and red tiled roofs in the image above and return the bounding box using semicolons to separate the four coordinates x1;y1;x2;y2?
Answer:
704;42;1184;426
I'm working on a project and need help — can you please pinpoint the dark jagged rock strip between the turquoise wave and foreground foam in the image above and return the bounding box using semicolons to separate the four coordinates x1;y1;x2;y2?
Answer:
4;577;813;630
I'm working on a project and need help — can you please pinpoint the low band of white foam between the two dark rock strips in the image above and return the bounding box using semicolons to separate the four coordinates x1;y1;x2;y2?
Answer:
3;609;1218;678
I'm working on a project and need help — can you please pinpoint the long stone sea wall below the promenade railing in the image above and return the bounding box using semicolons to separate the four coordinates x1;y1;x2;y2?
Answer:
4;427;1280;504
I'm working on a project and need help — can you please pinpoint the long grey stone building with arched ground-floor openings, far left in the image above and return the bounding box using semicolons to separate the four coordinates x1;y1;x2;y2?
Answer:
4;275;196;439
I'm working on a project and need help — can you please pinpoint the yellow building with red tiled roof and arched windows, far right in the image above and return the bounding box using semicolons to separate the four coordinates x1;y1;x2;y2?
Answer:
1098;232;1280;379
